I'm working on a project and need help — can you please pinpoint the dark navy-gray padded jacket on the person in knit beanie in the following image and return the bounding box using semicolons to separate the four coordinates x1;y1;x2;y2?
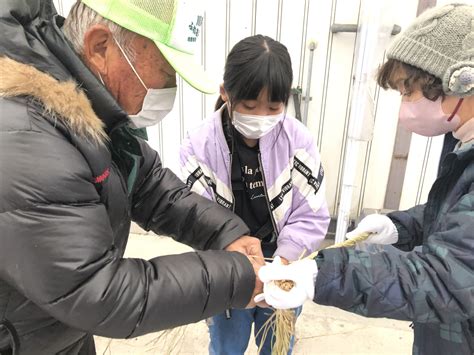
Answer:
315;144;474;355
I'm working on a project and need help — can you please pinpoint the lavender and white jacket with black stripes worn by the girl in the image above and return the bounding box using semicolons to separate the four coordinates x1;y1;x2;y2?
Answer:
180;110;330;260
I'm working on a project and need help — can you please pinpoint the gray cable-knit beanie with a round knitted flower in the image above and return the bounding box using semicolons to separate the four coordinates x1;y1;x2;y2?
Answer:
387;4;474;97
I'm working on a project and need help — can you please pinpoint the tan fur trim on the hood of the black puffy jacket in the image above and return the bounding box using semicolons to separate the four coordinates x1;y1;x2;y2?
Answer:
0;57;108;144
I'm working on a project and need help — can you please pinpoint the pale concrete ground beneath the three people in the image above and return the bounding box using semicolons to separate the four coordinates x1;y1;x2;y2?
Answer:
96;234;413;355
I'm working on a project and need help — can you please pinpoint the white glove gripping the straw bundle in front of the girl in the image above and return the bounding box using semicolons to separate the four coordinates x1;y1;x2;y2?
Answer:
255;256;318;309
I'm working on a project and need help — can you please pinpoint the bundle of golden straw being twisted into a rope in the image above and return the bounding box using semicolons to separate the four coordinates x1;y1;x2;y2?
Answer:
258;233;372;355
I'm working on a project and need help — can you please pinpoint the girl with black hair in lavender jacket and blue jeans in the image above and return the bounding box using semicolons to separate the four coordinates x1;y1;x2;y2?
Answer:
181;35;329;354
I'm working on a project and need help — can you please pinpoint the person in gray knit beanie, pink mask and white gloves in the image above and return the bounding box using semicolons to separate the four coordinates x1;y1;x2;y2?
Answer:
259;4;474;355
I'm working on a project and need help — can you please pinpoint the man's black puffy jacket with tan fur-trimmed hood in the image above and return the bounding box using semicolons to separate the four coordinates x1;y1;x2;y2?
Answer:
0;0;255;354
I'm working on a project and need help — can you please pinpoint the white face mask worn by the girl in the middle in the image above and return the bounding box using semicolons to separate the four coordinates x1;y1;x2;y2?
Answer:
232;111;285;139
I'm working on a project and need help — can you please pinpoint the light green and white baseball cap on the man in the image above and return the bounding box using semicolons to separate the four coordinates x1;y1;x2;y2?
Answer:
82;0;219;94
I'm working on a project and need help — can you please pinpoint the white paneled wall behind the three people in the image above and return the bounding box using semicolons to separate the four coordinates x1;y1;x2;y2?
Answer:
55;0;446;220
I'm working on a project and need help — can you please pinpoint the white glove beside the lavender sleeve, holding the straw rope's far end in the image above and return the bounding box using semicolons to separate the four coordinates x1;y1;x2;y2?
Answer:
346;214;398;244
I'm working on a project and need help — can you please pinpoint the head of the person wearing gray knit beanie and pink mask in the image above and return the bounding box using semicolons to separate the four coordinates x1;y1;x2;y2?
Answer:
378;4;474;144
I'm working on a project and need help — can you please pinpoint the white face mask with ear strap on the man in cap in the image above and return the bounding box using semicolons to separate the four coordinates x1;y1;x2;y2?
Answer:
115;40;177;128
